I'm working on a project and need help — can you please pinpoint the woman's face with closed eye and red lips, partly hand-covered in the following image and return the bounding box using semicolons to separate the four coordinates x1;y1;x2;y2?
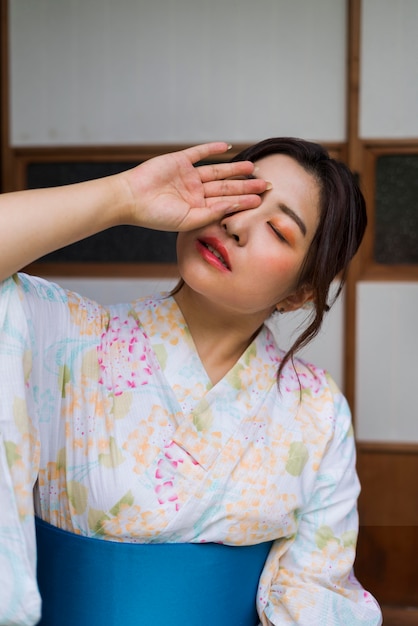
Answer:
177;154;319;317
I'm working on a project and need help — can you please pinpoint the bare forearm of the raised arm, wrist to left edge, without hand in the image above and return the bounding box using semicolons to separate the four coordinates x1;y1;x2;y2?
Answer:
0;176;130;280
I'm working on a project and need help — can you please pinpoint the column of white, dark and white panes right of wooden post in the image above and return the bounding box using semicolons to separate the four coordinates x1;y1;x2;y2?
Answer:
356;0;418;443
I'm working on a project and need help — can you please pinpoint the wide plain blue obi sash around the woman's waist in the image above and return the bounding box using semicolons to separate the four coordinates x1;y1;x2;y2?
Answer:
36;519;272;626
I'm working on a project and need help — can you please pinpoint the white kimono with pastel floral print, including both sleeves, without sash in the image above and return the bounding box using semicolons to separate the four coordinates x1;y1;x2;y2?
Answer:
0;274;381;626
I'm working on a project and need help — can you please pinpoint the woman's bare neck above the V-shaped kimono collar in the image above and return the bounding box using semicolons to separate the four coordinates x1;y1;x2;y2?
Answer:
174;285;264;385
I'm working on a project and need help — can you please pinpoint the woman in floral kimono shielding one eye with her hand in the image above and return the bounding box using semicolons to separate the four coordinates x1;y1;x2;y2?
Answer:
0;138;381;626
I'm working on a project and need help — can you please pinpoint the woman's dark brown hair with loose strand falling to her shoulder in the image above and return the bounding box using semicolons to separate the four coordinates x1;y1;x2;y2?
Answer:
231;137;367;378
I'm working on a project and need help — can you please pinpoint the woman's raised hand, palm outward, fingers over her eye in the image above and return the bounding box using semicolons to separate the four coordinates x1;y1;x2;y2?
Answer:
124;142;267;231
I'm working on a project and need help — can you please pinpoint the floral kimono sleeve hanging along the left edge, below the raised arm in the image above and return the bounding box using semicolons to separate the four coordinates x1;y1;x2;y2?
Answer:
0;278;41;626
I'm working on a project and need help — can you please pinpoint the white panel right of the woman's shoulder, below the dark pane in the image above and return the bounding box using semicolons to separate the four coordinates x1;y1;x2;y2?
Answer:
356;282;418;443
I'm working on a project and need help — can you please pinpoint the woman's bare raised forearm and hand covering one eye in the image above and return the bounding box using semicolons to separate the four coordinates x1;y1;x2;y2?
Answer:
0;142;267;280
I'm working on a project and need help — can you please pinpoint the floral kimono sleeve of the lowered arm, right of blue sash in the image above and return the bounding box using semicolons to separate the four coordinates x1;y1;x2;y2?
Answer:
258;392;382;626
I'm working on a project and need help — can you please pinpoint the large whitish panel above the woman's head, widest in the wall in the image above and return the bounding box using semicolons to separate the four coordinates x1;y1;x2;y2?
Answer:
9;0;346;146
